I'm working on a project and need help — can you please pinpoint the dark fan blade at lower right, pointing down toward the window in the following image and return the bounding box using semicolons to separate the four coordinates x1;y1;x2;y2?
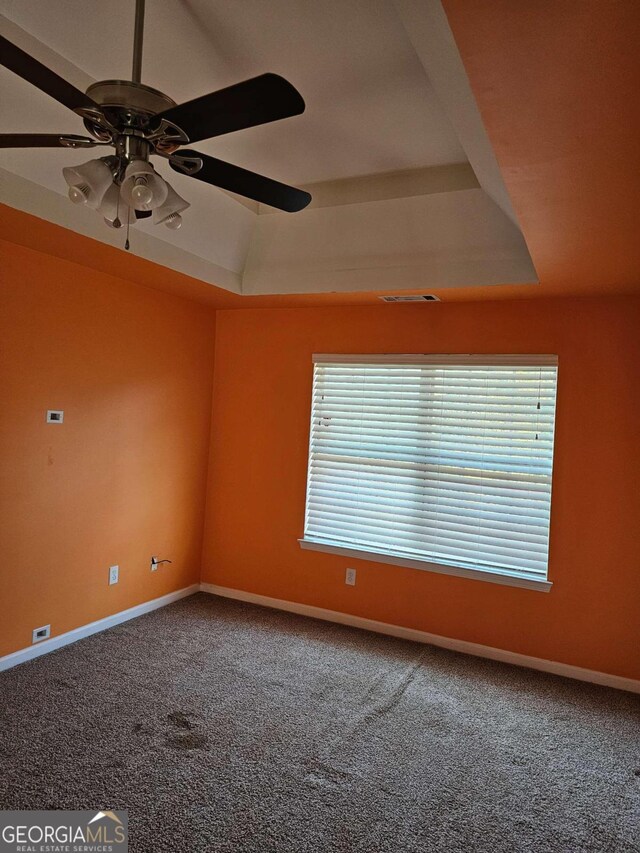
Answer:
169;149;311;213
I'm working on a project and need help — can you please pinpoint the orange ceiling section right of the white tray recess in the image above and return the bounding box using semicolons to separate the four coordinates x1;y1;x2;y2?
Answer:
444;0;640;295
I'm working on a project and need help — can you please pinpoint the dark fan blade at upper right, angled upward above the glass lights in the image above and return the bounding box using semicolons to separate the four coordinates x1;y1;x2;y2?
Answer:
158;74;305;142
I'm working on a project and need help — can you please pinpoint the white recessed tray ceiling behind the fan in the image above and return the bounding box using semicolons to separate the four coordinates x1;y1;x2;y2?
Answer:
0;0;535;293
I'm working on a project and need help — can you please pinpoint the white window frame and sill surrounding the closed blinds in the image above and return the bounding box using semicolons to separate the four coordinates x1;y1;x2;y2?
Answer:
298;353;558;592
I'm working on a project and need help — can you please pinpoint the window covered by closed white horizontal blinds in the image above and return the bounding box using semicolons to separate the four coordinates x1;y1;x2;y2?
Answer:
300;355;557;590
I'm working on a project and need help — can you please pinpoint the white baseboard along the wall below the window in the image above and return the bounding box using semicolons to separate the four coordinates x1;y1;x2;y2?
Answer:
200;583;640;693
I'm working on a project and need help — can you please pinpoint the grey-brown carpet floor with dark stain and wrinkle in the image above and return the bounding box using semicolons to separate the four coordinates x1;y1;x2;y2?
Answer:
0;594;640;853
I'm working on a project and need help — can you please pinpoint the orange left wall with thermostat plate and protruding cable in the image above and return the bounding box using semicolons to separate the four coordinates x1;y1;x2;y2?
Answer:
0;243;215;654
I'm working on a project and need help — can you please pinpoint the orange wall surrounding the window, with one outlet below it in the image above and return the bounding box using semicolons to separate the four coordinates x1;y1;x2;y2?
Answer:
202;297;640;678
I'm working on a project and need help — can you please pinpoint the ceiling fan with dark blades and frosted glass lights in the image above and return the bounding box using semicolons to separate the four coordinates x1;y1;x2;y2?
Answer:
0;0;311;241
